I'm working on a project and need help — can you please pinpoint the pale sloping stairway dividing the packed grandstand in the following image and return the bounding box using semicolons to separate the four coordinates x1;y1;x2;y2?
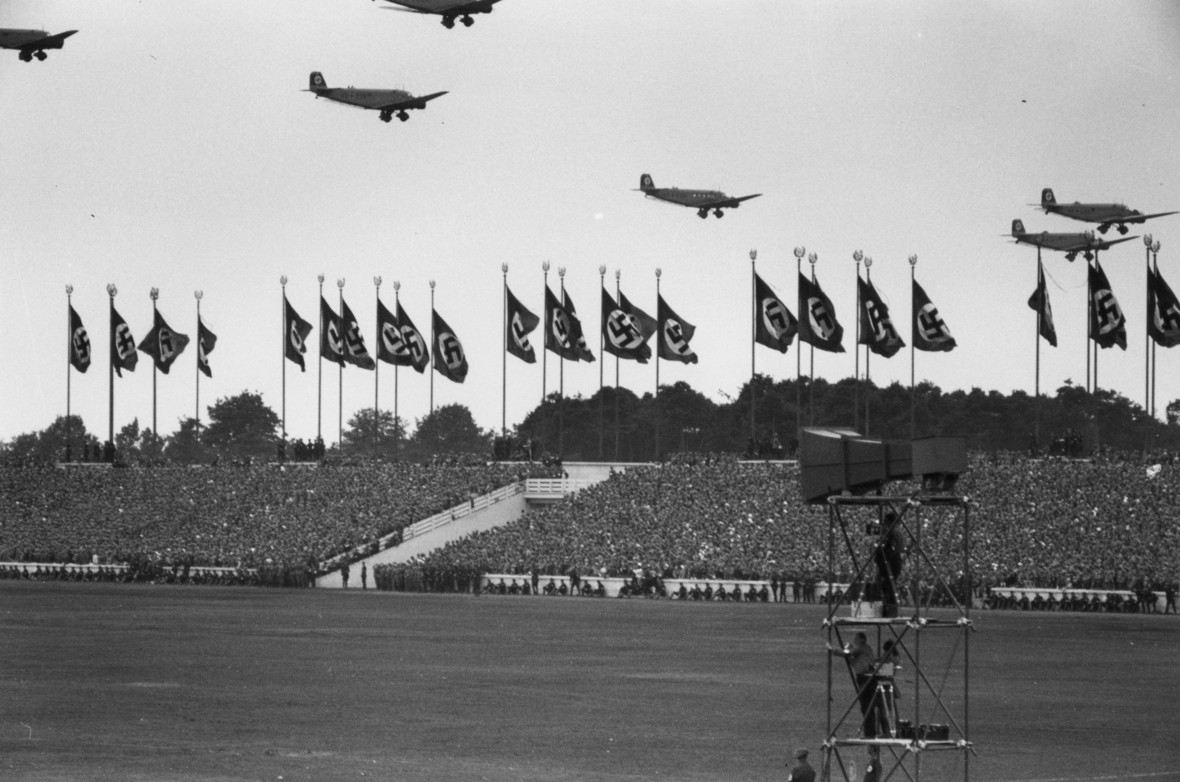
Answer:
315;462;640;589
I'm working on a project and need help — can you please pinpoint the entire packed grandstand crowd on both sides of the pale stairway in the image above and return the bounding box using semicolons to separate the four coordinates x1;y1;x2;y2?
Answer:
0;454;1180;601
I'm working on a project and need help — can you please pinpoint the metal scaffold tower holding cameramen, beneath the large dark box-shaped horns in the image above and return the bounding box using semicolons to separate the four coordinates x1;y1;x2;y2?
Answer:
820;493;975;782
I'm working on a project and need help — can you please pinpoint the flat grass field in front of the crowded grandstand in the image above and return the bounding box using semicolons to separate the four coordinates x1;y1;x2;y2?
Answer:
0;581;1180;782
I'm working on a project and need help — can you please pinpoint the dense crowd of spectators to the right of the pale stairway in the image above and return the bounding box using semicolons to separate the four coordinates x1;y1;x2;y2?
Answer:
421;454;1180;594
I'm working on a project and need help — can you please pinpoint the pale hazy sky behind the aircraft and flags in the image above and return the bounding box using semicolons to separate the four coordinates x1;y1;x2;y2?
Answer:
0;0;1180;442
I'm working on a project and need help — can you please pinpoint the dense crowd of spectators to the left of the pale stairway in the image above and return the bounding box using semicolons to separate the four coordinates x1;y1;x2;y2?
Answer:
0;461;555;572
